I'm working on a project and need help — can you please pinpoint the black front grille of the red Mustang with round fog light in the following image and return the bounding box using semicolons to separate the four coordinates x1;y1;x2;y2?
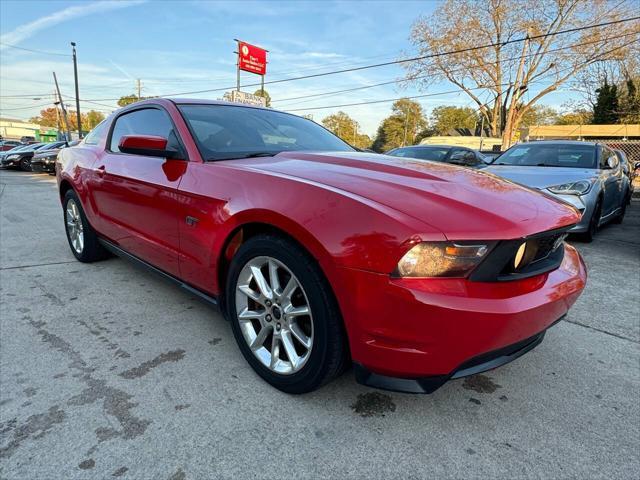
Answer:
469;226;571;282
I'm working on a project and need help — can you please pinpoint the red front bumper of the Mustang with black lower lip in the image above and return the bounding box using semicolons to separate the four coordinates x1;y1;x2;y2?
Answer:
336;245;587;392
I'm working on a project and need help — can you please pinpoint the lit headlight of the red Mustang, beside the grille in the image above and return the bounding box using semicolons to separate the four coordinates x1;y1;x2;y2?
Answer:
394;242;492;277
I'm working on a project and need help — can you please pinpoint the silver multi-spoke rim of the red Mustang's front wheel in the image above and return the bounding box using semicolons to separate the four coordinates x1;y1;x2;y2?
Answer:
236;256;313;375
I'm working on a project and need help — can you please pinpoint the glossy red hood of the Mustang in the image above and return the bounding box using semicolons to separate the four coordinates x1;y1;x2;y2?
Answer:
224;152;580;240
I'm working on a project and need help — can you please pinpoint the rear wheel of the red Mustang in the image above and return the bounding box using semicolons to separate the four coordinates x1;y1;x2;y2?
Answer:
63;190;107;263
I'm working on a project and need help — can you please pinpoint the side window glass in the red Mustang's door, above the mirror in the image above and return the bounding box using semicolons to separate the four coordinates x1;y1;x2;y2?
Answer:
109;108;180;152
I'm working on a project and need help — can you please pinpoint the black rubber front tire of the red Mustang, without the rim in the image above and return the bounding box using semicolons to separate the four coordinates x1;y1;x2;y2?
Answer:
226;234;348;394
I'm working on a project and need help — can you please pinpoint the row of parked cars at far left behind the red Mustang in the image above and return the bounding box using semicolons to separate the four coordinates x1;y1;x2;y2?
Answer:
0;141;78;173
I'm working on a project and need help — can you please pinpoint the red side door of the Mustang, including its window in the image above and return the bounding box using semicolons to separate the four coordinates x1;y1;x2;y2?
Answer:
91;105;186;275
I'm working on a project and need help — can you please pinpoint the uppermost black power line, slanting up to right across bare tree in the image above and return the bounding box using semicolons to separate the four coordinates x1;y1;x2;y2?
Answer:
76;16;640;101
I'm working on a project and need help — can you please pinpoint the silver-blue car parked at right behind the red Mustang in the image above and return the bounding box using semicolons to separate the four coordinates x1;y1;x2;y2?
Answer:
484;141;631;241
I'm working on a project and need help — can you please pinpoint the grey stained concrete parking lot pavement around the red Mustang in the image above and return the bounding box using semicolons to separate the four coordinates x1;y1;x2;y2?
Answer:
0;171;640;480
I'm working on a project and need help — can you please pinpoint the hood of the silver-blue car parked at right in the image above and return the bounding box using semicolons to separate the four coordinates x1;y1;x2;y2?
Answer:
484;165;598;188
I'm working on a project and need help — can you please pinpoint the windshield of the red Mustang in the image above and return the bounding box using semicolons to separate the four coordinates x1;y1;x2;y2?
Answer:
179;104;354;160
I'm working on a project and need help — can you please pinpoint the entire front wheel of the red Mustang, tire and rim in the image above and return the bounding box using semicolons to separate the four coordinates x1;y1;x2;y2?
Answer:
226;235;347;393
